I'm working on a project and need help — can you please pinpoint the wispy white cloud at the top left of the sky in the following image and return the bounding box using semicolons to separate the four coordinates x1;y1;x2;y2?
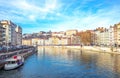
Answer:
0;0;60;19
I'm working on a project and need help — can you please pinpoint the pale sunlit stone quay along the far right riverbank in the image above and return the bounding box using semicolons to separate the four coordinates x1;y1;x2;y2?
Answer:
39;46;120;54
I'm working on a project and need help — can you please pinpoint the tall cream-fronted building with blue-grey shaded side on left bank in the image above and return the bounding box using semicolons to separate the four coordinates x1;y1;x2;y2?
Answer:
0;20;22;45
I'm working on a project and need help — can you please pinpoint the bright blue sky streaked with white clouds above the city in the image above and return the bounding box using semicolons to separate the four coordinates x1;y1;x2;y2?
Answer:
0;0;120;33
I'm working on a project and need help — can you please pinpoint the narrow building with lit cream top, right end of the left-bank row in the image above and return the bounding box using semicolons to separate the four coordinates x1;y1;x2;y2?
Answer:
15;26;22;45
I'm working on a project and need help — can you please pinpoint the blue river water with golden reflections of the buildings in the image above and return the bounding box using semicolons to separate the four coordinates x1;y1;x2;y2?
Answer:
0;47;120;78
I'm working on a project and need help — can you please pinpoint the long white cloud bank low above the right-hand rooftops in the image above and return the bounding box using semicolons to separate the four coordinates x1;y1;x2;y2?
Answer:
50;4;120;31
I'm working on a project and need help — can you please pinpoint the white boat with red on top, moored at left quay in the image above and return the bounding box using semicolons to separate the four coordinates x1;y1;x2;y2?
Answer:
4;55;24;70
